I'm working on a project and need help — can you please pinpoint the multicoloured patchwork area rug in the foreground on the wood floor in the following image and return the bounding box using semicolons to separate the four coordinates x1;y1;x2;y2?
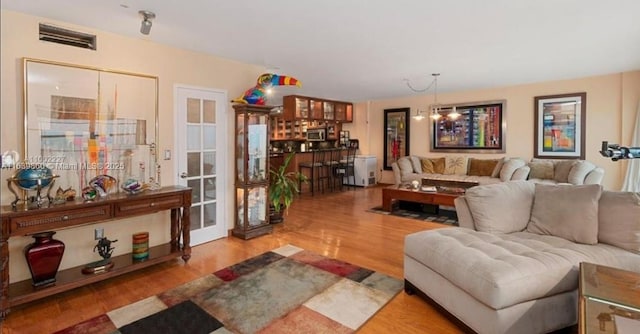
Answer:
58;245;403;334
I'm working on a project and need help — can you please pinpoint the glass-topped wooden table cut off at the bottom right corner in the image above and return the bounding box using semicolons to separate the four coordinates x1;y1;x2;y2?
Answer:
578;262;640;334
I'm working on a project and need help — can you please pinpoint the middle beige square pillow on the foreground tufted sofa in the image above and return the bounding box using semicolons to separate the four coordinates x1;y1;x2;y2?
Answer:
527;183;602;245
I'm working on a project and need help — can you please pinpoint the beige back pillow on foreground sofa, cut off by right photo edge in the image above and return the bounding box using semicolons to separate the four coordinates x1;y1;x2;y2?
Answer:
598;191;640;253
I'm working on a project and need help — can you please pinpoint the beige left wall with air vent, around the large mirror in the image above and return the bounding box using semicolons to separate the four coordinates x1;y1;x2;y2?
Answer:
0;10;264;282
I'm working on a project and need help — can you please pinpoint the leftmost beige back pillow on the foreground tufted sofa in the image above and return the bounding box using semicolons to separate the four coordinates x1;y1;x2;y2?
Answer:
464;181;535;233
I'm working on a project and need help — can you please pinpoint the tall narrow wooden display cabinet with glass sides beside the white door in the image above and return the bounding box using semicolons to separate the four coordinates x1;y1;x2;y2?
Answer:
231;104;273;239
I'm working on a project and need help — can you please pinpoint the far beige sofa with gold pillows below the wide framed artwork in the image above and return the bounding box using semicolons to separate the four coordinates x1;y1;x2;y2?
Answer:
391;155;529;184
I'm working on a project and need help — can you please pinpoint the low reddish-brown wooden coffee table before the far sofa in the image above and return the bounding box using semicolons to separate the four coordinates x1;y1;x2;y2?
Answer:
382;185;463;212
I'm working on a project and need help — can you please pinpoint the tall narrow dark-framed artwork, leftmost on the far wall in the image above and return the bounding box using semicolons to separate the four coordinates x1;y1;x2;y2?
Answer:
383;108;410;170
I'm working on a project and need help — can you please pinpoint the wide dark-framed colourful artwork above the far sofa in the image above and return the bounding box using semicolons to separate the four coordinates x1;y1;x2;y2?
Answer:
431;100;507;153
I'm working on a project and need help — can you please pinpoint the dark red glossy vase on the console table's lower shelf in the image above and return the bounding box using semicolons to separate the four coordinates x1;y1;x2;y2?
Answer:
24;231;64;287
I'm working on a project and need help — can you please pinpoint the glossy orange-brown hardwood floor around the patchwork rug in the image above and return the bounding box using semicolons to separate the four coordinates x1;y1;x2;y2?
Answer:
2;187;461;334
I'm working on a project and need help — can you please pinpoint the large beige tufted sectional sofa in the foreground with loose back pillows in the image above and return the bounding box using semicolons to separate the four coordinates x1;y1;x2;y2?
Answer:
404;181;640;333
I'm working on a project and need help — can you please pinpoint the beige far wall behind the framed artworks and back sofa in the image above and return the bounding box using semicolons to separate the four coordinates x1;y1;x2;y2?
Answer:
344;71;640;190
